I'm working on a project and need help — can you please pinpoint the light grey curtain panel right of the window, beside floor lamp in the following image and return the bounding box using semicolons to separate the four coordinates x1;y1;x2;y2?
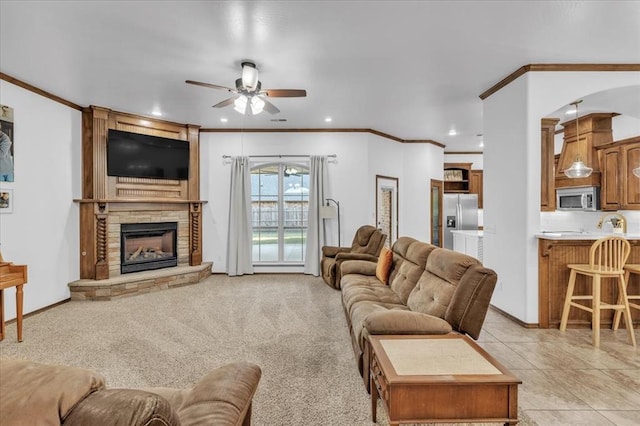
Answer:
304;155;327;277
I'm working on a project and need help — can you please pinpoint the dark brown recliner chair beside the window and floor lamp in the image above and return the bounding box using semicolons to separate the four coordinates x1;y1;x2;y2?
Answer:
320;225;387;289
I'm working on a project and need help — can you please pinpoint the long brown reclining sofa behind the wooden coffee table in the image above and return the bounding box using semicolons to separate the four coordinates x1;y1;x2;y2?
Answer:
340;237;497;389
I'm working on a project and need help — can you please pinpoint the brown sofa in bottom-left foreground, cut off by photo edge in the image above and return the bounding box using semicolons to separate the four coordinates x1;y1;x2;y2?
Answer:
0;359;261;426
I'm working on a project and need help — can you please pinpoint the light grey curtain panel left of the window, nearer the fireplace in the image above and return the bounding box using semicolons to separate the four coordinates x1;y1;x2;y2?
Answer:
227;157;253;276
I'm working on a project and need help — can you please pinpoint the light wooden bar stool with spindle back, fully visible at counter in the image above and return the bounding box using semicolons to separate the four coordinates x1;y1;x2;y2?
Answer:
560;236;636;348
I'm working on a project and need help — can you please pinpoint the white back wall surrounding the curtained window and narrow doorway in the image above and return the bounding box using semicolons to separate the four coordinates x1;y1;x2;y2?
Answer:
200;132;443;272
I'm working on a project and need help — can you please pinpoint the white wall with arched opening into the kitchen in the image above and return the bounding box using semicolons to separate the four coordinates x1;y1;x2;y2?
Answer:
483;72;640;323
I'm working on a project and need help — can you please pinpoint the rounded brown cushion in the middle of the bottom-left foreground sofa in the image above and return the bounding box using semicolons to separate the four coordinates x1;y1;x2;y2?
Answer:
63;389;180;426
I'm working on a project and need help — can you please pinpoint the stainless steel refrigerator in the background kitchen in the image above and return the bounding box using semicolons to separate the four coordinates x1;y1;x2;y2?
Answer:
442;194;478;250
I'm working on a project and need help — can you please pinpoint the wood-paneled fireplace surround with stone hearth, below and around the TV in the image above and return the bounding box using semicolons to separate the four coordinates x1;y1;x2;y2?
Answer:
69;106;212;300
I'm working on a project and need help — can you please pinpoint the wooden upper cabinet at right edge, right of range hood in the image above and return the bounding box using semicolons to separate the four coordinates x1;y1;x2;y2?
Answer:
598;136;640;210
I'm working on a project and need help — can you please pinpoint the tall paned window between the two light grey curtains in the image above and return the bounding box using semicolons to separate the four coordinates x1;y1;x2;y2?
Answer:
251;163;309;265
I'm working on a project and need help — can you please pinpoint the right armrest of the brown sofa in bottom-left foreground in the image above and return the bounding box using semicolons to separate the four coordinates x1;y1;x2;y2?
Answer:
144;361;262;426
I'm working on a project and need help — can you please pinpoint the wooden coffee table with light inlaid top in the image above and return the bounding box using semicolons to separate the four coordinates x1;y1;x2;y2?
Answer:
368;335;522;425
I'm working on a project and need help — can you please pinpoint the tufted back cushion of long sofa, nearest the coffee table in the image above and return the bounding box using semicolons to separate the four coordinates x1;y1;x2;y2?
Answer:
407;248;479;318
